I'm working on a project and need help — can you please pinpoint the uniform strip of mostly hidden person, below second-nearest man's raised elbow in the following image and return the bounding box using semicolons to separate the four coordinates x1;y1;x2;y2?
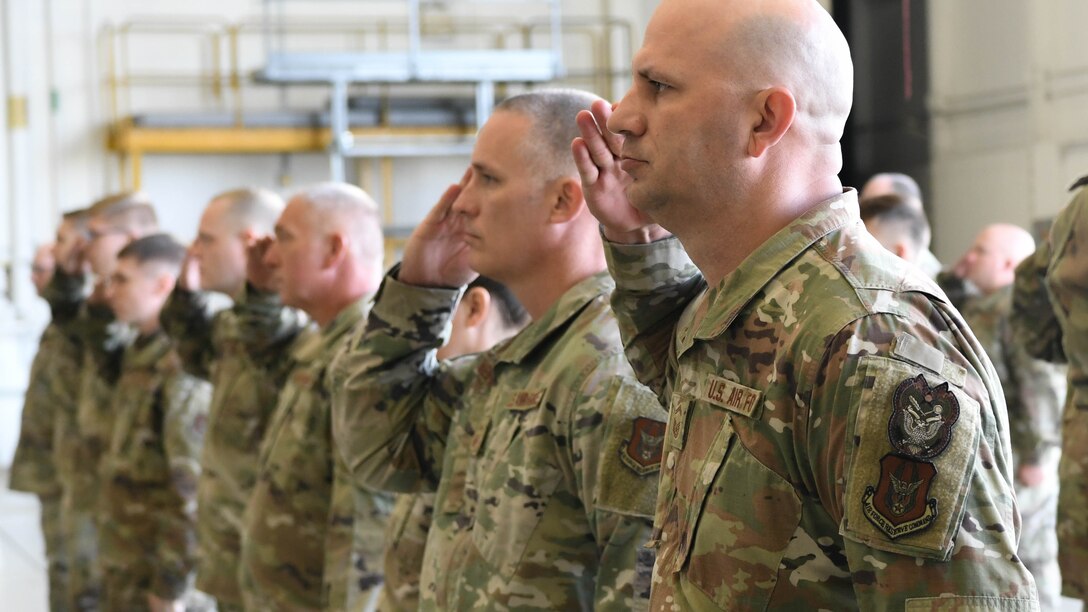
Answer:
378;493;434;612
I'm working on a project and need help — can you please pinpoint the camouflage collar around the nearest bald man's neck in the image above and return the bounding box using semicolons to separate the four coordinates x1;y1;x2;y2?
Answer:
677;188;861;354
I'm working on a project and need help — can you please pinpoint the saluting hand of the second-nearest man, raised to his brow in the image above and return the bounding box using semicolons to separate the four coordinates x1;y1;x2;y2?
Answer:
397;168;479;287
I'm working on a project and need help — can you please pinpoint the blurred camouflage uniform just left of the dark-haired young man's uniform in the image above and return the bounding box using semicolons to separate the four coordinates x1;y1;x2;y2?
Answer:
46;270;132;611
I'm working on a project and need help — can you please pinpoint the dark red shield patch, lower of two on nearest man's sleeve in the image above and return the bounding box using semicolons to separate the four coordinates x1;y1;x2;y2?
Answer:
862;453;937;539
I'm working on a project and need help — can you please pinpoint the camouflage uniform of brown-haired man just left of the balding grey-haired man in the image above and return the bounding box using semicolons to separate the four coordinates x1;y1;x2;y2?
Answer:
161;286;305;612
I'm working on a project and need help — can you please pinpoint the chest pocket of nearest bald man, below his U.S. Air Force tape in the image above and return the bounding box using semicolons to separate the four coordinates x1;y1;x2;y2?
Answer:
657;392;801;610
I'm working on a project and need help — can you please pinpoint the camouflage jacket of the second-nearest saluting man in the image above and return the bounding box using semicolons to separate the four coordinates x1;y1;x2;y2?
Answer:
334;272;665;611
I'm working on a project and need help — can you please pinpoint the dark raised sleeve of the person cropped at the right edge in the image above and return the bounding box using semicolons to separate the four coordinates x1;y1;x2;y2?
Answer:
1011;240;1065;364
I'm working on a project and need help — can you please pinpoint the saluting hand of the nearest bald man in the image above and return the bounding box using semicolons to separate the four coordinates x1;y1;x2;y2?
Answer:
570;100;668;244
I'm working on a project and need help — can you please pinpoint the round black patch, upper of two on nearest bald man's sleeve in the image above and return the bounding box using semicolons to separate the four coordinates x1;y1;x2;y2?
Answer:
888;374;960;460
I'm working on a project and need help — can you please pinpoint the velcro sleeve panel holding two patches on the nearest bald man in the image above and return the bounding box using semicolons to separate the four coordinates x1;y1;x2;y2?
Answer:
841;355;981;561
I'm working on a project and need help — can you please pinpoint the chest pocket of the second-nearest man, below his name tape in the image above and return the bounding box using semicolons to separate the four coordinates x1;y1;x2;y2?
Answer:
472;389;560;579
